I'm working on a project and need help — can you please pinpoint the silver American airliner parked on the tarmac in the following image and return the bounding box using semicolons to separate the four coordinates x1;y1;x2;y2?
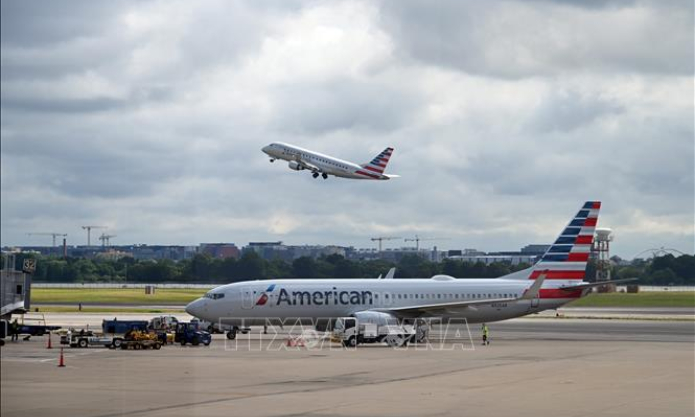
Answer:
186;201;631;339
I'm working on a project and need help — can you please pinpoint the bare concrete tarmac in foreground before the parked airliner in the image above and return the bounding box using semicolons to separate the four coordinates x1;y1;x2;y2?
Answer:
0;314;695;417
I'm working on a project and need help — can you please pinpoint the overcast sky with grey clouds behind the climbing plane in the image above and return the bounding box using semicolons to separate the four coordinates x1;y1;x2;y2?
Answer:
0;0;695;258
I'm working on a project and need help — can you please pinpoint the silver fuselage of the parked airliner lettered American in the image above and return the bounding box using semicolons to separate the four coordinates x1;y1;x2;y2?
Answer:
186;277;582;326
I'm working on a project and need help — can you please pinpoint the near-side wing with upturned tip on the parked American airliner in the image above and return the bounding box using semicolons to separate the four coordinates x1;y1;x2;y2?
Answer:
373;274;545;317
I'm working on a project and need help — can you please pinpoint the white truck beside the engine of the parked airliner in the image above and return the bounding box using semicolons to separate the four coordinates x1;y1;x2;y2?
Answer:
333;317;416;347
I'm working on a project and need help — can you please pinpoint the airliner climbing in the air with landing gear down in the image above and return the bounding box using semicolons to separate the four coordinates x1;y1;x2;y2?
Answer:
261;142;398;180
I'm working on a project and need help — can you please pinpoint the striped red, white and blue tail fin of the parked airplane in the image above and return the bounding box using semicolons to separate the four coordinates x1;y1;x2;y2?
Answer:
501;201;601;284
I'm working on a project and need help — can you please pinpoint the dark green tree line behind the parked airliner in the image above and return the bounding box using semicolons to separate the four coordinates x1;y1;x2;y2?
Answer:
3;252;695;285
